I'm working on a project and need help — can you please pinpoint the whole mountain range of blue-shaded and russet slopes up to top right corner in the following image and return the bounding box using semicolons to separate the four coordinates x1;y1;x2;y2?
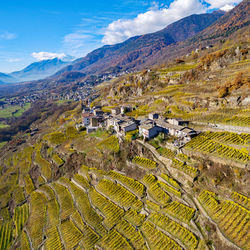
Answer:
0;0;249;93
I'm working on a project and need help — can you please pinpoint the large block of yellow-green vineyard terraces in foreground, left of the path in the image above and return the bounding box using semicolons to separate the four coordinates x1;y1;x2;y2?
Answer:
0;162;207;249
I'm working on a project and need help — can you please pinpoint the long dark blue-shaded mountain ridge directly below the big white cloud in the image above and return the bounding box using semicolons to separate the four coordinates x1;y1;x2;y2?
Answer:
56;12;223;75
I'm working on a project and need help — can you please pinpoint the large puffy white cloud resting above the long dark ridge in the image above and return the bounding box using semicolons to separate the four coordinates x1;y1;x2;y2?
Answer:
102;0;206;44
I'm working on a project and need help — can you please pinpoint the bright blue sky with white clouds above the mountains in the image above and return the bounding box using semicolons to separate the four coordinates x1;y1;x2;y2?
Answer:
0;0;241;73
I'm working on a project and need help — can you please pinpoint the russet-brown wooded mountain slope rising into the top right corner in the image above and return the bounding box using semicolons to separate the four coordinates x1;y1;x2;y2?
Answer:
149;0;250;67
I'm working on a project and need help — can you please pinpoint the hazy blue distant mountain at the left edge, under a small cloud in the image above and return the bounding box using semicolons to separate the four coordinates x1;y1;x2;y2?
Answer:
0;58;70;84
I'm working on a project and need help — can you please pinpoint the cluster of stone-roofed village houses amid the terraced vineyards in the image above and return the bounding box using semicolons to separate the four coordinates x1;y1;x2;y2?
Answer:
77;106;197;142
